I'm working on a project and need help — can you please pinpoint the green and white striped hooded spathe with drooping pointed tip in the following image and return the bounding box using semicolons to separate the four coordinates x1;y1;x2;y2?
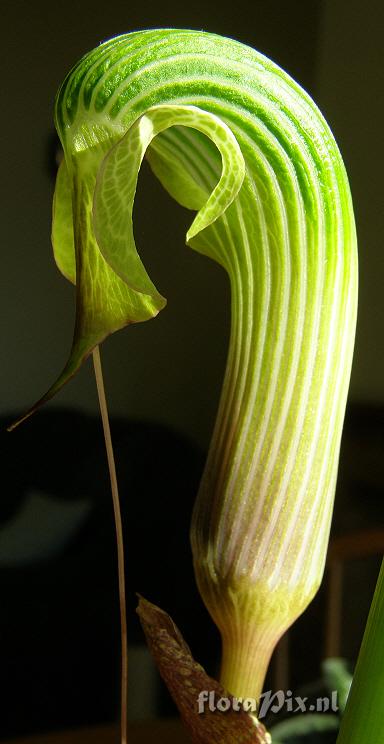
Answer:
21;29;357;697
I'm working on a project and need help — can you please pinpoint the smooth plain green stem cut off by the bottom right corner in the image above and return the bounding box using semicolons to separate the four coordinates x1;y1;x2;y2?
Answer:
337;561;384;744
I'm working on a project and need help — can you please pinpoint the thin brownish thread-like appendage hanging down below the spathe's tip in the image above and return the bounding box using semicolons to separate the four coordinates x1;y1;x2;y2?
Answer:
93;346;128;744
